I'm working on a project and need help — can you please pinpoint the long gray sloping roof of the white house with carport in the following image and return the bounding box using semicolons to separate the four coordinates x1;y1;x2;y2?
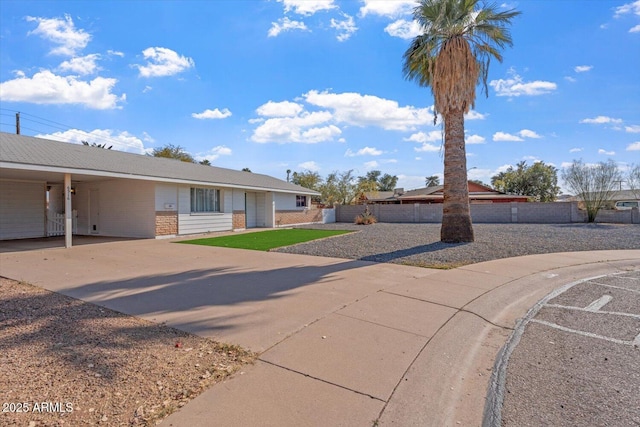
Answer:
0;132;319;194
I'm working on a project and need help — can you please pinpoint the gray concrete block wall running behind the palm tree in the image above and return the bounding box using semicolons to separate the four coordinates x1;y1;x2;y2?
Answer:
336;202;640;224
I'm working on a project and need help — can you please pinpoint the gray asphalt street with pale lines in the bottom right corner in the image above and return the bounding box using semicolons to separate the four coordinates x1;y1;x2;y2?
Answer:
485;271;640;426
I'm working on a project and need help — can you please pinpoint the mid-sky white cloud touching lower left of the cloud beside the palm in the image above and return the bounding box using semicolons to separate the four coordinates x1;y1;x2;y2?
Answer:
251;111;342;144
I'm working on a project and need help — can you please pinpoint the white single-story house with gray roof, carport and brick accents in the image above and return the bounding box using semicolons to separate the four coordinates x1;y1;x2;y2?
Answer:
0;132;322;246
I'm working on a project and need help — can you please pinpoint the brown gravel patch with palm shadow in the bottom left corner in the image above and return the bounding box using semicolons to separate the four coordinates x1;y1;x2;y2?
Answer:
0;278;255;426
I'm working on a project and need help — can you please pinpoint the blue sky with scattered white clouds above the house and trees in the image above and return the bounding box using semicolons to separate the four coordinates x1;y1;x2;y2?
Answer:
0;0;640;189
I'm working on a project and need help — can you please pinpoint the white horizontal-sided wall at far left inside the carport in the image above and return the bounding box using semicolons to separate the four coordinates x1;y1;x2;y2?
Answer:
0;181;46;240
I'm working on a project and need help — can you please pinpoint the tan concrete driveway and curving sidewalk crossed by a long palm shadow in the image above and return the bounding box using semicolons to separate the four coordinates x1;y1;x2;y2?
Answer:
0;240;640;426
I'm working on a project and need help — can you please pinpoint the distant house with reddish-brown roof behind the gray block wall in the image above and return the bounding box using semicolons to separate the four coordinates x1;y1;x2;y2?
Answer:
360;181;529;205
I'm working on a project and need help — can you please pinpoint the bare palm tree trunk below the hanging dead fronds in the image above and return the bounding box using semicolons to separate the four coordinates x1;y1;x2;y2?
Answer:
440;110;473;243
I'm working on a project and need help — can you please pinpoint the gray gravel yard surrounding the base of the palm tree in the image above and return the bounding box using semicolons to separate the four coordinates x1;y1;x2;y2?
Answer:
275;223;640;268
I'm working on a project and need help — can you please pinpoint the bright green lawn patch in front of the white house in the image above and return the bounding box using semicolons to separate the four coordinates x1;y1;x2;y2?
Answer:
178;228;350;251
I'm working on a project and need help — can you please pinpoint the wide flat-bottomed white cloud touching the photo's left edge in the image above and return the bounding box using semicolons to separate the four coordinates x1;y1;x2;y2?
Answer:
0;70;126;110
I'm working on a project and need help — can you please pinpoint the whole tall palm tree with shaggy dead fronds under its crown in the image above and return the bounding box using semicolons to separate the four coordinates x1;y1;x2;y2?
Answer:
403;0;520;243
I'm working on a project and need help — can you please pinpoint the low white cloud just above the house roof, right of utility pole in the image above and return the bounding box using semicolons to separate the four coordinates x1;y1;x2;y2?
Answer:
36;129;148;154
